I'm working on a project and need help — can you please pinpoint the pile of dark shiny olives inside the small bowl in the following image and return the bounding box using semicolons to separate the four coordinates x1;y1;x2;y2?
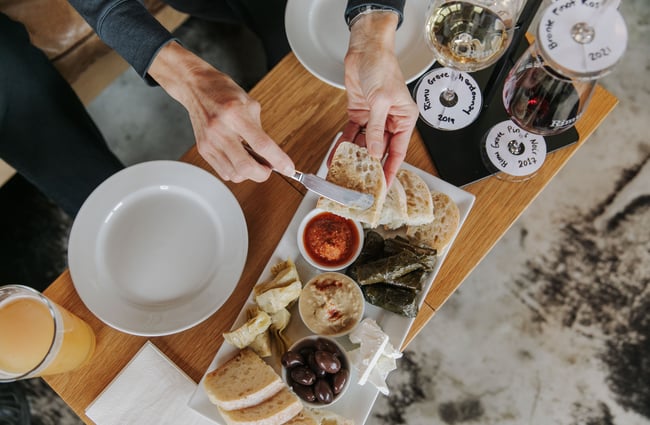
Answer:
282;338;350;404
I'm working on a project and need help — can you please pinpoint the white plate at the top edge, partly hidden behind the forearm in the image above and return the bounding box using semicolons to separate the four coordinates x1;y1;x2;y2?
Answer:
285;0;434;88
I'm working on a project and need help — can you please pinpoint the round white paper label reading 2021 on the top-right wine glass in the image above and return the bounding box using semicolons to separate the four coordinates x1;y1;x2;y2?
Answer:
537;0;627;78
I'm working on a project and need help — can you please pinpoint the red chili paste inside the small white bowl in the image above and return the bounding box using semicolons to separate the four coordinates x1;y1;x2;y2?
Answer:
303;212;359;267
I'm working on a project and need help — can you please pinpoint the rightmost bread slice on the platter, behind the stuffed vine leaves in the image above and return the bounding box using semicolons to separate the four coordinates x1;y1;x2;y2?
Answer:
406;191;460;252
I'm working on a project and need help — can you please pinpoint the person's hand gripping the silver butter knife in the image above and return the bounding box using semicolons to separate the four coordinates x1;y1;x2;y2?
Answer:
149;42;294;183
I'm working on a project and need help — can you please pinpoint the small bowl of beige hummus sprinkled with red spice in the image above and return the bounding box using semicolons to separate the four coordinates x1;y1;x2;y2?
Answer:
298;272;365;337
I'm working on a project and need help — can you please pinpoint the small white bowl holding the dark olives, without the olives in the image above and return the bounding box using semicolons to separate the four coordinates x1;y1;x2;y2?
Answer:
282;335;352;408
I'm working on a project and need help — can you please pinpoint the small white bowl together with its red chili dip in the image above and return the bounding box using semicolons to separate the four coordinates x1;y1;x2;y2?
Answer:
298;209;363;271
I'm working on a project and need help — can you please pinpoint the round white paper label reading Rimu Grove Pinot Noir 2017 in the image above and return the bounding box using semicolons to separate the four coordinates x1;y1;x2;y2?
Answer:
484;120;546;177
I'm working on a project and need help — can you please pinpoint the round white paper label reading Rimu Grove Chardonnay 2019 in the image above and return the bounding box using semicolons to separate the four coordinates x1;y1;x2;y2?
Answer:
415;68;483;130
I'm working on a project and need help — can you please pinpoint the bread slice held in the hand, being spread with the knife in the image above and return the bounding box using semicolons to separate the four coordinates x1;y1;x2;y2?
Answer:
316;142;387;227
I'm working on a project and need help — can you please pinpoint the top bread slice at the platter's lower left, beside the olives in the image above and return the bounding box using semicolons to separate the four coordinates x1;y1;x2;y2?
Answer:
203;348;286;410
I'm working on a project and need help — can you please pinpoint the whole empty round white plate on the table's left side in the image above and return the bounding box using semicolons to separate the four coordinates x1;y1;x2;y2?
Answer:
68;161;248;336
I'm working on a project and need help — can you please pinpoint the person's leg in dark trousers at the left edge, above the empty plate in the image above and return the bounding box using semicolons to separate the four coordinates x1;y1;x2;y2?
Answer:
0;14;124;217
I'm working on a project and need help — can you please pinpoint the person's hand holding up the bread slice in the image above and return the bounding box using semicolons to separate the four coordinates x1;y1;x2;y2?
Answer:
333;12;418;185
